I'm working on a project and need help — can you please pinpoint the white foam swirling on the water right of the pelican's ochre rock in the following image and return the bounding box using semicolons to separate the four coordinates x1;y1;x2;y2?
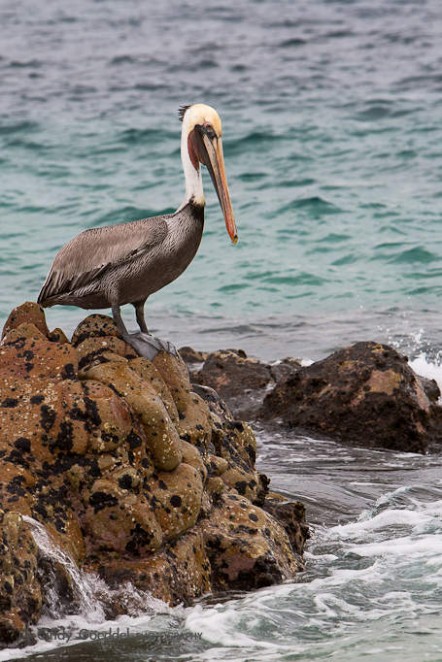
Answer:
185;486;442;662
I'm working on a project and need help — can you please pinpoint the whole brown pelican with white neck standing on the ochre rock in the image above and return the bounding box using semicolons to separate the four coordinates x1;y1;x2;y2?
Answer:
38;103;238;358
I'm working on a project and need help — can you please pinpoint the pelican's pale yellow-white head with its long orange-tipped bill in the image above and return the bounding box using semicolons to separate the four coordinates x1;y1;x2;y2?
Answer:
180;103;238;244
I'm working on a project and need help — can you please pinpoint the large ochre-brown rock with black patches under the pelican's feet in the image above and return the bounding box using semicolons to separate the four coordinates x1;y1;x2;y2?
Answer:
0;303;306;645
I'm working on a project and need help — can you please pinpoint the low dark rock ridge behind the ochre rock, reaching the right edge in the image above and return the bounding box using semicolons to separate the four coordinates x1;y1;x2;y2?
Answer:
183;342;442;453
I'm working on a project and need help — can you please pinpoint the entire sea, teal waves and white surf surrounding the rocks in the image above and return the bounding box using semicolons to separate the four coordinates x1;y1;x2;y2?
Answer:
0;0;442;662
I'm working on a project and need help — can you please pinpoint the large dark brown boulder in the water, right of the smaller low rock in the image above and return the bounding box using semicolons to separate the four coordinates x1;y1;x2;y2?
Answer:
260;342;437;453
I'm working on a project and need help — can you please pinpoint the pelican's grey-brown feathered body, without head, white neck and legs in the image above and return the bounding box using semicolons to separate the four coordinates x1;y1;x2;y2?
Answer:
38;202;204;318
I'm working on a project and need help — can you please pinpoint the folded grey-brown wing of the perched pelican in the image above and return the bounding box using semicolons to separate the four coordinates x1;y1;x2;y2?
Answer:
38;216;168;305
